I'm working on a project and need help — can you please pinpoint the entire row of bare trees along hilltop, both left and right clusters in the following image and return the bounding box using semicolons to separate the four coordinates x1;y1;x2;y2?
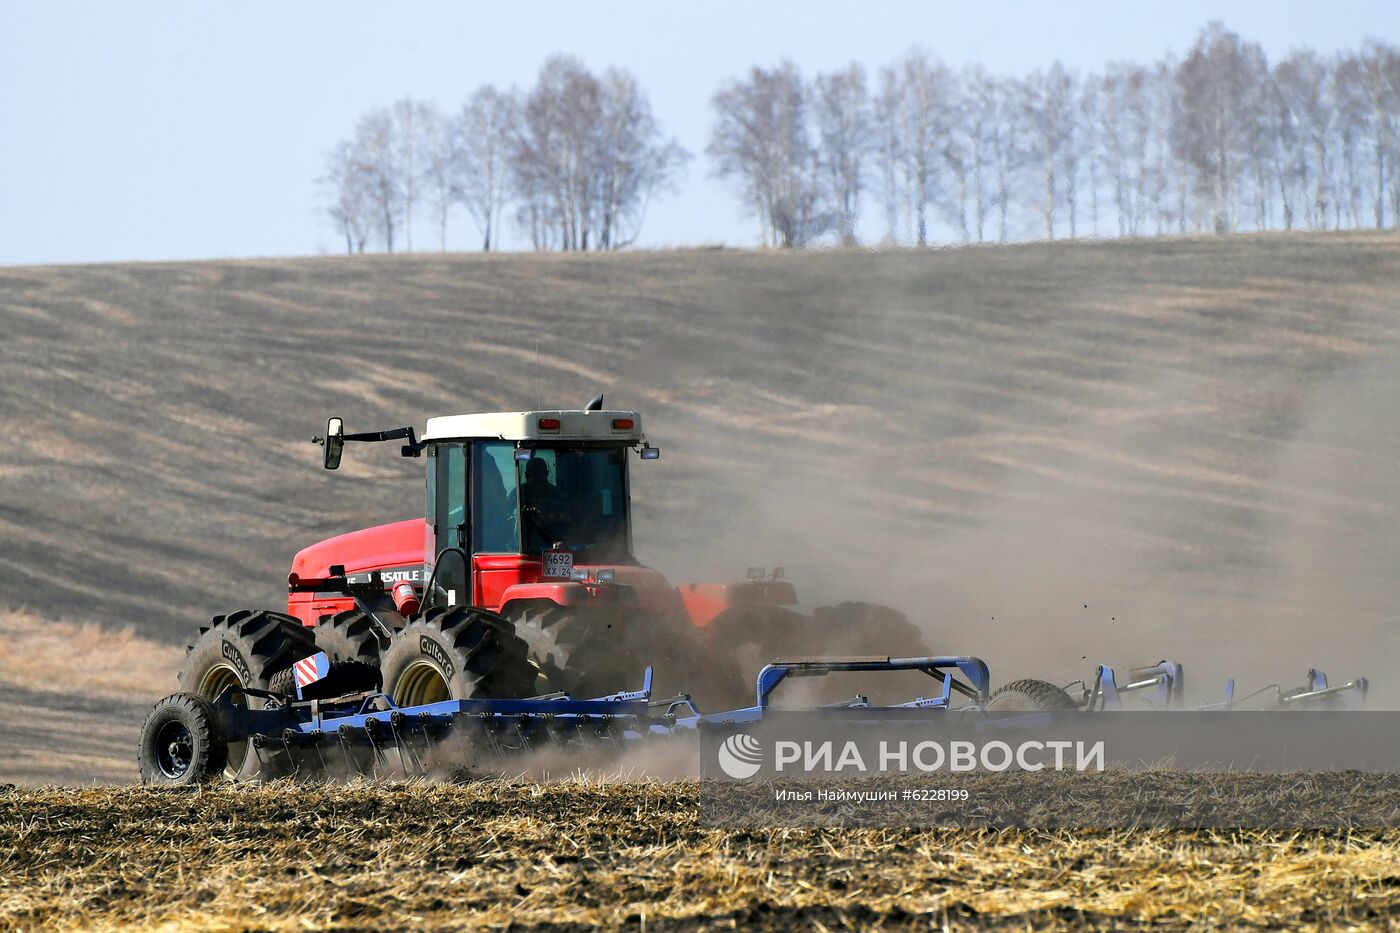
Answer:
323;24;1400;251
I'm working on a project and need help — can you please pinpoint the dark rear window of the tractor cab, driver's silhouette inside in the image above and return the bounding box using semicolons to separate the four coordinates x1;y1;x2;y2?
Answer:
515;447;631;563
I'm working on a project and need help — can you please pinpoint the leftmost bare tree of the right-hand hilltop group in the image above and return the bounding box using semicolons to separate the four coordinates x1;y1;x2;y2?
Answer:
707;62;830;247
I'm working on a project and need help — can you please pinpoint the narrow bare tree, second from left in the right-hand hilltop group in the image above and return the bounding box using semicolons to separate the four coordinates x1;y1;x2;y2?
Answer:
816;64;872;247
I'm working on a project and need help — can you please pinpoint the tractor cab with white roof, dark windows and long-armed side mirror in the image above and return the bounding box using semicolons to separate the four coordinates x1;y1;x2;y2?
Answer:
304;402;675;611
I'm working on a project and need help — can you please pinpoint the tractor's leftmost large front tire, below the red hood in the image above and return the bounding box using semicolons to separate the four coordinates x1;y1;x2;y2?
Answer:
179;609;318;778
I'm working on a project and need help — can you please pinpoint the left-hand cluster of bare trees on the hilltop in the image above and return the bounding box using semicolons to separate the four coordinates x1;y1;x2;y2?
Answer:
321;55;689;252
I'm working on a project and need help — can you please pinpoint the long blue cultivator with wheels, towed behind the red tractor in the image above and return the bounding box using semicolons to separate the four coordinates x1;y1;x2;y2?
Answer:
140;657;1366;785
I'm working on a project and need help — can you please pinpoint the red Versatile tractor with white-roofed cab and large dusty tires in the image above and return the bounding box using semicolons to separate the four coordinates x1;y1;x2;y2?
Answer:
181;396;927;756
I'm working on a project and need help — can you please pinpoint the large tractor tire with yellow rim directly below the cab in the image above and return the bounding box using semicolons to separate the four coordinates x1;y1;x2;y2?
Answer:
379;607;538;706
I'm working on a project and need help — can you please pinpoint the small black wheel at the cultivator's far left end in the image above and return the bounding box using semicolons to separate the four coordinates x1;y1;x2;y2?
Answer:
137;693;228;785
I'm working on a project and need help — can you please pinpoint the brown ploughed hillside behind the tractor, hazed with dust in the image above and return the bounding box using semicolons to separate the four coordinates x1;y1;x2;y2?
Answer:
0;234;1400;711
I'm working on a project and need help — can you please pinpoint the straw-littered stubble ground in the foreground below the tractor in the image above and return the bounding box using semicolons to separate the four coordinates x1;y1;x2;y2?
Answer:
0;780;1400;930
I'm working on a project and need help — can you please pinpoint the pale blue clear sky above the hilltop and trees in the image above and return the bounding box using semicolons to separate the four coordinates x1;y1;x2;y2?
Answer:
0;0;1400;265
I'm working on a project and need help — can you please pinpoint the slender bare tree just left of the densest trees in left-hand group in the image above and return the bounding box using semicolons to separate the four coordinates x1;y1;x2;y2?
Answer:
452;84;519;252
